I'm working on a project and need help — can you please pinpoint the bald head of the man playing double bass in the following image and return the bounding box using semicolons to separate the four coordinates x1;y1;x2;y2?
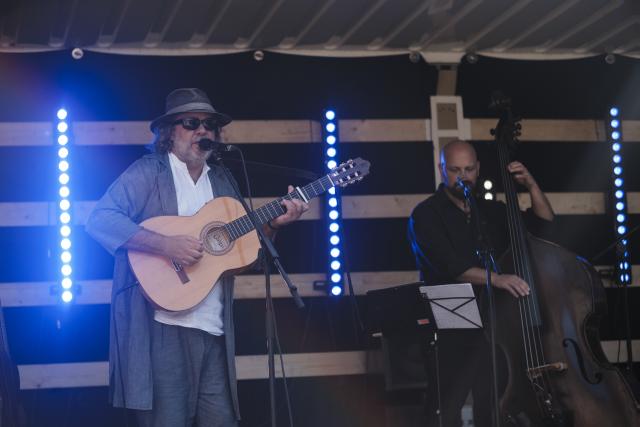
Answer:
438;140;480;198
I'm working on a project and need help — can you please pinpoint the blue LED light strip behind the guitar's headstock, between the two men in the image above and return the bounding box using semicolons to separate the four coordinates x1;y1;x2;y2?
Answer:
322;110;344;296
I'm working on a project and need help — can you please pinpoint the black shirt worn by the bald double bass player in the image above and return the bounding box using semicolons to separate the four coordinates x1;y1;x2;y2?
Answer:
408;184;547;285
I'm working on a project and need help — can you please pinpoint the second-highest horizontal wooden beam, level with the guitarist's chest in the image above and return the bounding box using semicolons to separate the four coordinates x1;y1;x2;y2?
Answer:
0;192;640;227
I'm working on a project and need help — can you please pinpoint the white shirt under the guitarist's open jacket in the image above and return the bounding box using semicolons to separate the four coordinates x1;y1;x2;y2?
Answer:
154;153;224;335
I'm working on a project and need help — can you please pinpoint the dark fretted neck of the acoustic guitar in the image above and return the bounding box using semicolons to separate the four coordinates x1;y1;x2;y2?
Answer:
225;175;333;240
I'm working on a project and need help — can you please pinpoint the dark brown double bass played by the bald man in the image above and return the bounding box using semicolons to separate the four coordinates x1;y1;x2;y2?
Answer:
492;95;640;427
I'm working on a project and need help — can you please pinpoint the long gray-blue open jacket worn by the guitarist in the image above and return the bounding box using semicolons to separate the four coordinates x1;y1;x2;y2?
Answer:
86;154;240;419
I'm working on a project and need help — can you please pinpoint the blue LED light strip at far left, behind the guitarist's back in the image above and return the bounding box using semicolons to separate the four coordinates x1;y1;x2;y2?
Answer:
54;108;73;303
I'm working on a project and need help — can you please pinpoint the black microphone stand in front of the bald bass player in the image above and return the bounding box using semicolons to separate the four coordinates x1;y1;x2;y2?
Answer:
458;177;500;427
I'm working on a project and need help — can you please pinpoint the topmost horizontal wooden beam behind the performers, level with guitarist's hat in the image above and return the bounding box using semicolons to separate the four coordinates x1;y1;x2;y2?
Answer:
5;118;640;146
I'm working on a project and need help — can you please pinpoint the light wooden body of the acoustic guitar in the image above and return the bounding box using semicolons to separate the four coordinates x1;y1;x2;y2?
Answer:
129;197;260;311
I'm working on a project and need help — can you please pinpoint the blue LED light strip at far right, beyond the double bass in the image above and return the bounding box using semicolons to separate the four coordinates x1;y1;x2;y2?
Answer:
607;107;633;286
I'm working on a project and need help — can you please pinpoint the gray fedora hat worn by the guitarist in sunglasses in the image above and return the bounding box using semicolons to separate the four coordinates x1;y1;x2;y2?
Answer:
149;88;231;132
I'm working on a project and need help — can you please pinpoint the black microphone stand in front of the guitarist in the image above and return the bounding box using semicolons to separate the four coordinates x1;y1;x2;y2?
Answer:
211;147;304;427
